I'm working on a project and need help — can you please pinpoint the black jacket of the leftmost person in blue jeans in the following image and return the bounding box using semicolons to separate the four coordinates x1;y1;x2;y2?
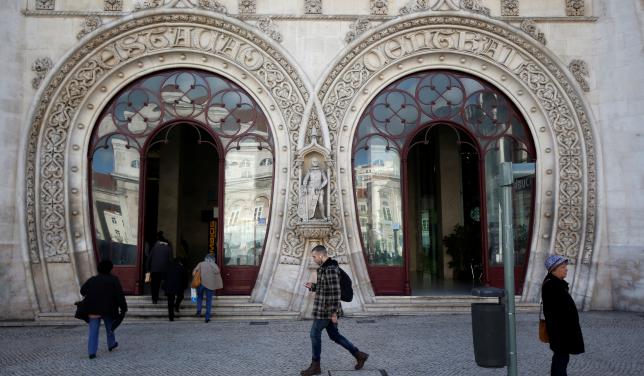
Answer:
81;274;127;318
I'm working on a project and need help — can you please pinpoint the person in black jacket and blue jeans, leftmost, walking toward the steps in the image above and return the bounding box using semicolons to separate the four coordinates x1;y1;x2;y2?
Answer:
80;260;127;359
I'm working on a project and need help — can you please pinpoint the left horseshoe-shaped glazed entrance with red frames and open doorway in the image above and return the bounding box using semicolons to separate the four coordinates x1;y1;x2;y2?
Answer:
89;70;273;294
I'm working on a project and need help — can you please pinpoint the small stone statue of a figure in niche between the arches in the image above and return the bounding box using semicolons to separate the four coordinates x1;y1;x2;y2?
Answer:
297;158;328;221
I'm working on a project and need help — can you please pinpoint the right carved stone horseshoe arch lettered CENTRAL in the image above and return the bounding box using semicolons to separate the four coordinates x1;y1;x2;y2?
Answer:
316;11;599;307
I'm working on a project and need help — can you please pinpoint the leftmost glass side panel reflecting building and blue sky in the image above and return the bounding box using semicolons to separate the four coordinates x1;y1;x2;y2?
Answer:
92;137;139;265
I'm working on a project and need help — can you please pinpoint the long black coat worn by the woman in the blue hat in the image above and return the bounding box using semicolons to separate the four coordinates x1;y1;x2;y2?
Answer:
541;273;585;354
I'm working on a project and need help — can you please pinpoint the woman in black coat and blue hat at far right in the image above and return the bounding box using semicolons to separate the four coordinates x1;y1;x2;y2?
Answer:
541;255;585;376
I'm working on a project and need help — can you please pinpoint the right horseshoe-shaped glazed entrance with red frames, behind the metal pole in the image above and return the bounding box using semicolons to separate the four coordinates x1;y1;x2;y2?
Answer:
353;70;536;294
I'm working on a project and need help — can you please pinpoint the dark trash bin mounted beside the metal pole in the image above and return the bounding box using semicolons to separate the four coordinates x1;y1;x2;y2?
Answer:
472;287;507;368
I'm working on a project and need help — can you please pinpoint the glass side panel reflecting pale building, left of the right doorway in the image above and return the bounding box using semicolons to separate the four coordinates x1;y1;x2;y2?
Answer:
354;145;403;265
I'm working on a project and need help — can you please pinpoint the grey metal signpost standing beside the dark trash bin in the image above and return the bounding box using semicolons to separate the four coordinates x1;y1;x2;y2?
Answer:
500;162;517;376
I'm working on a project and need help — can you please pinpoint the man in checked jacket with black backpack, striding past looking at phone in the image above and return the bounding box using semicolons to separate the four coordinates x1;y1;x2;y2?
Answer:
300;245;369;376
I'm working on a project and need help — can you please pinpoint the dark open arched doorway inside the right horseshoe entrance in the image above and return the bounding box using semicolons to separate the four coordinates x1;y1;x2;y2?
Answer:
405;124;483;295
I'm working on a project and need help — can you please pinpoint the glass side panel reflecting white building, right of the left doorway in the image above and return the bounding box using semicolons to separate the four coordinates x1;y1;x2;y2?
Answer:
223;142;273;265
